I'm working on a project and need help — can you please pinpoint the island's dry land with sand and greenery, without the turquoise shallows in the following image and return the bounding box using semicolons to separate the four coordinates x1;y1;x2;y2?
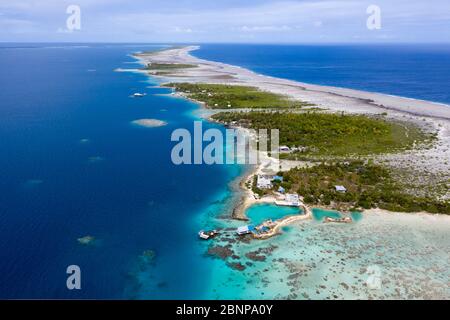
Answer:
135;46;450;219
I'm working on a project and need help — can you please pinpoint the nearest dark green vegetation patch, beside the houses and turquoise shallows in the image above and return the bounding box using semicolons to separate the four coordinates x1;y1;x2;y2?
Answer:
275;161;450;214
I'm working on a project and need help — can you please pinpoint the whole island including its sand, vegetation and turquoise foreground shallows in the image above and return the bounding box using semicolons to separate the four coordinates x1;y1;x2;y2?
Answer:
122;46;450;299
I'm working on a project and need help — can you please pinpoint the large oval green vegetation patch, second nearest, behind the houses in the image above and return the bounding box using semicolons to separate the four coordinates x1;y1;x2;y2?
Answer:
212;112;430;158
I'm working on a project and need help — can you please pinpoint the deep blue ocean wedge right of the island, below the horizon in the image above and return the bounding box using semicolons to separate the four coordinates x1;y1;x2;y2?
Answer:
193;44;450;103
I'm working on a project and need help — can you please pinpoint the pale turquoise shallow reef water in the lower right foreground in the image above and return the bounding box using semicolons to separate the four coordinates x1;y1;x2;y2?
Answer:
206;205;450;299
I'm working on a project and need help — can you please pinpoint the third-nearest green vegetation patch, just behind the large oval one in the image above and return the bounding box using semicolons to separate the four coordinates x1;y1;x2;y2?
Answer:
166;83;311;109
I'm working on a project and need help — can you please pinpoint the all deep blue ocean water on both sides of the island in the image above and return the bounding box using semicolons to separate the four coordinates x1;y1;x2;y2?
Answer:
0;44;450;299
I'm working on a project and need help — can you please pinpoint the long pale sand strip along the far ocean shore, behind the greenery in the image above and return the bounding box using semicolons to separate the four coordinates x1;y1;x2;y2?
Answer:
136;46;450;120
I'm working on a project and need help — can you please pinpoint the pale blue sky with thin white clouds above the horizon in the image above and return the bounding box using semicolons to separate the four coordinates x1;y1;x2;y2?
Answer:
0;0;450;43
